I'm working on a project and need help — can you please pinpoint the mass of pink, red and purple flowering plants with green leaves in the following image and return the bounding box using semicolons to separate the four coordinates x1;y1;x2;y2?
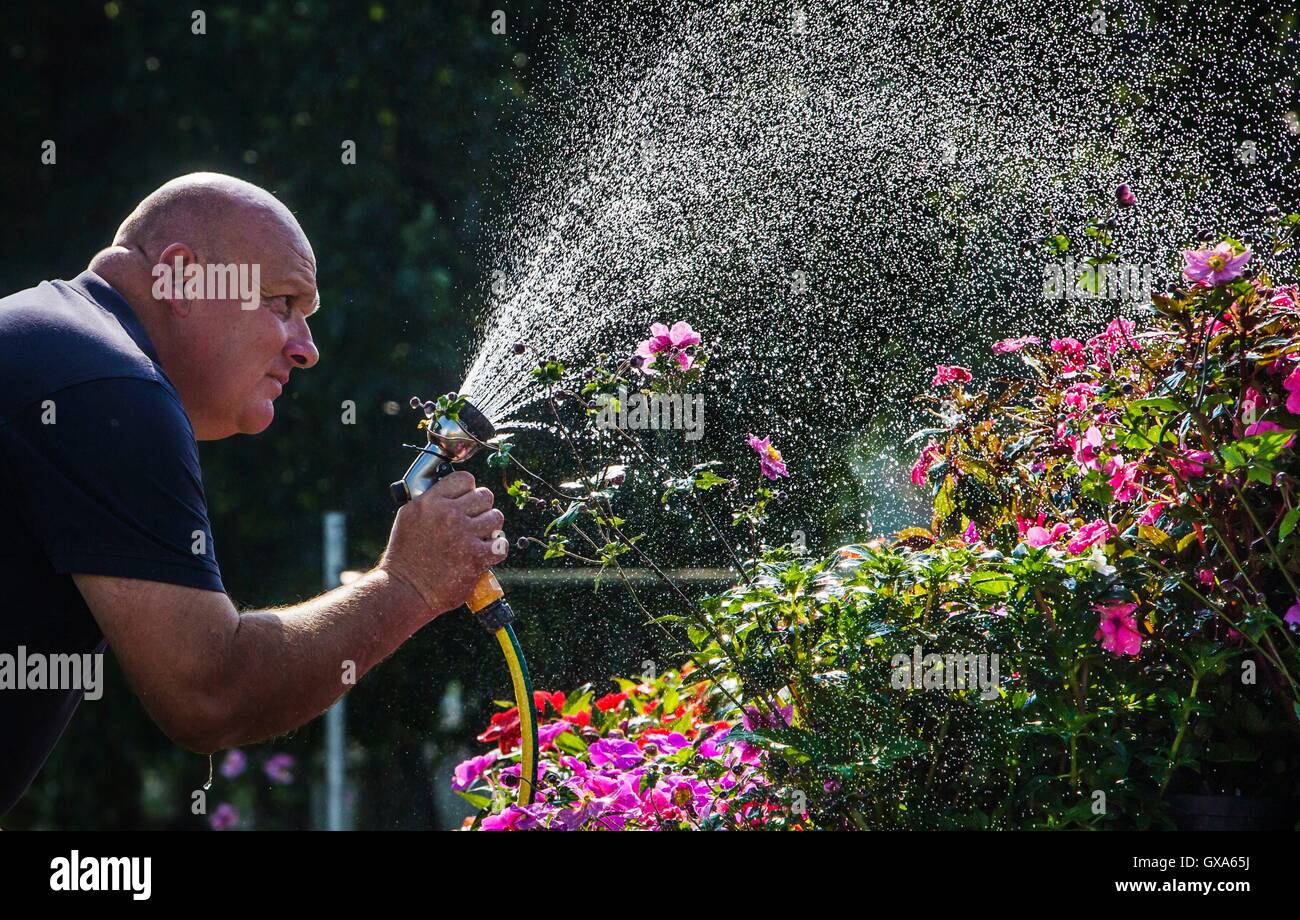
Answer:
458;228;1300;829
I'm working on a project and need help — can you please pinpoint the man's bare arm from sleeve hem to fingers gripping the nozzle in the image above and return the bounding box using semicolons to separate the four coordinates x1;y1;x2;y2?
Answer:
73;472;504;754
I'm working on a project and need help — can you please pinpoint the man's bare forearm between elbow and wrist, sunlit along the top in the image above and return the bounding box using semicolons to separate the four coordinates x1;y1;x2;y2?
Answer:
208;569;433;748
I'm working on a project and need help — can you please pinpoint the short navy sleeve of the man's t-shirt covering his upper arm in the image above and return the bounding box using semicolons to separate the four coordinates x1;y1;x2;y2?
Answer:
0;378;225;591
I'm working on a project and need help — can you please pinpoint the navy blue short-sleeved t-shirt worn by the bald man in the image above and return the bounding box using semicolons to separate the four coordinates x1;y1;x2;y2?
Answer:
0;272;225;815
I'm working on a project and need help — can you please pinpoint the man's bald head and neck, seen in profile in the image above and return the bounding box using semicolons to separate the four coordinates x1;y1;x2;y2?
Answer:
90;173;320;441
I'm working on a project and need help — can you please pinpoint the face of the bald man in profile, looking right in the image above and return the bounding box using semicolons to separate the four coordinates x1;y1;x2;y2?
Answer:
168;215;320;441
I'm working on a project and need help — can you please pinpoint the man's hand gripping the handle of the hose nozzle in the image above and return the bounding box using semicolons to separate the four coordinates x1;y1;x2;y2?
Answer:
378;470;510;616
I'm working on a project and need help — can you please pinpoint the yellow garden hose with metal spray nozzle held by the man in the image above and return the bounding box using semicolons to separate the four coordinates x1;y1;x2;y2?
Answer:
389;394;537;806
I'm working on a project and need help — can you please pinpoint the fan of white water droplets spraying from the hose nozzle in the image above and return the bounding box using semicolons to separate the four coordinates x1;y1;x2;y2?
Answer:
463;0;1300;532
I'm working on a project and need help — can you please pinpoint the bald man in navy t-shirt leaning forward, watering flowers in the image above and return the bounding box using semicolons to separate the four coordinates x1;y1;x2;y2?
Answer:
0;173;507;815
